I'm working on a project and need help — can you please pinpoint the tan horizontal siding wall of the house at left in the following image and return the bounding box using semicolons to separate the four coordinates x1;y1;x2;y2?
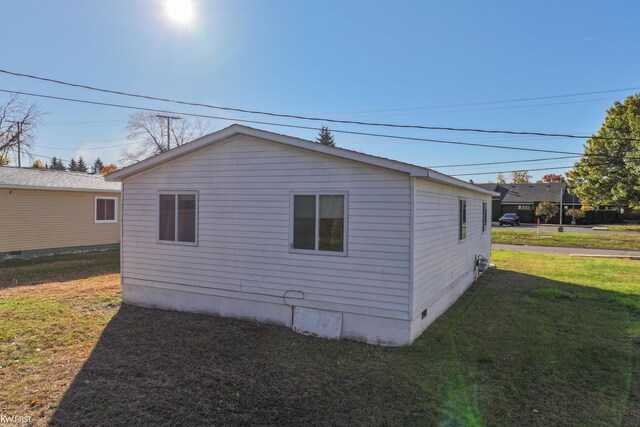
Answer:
0;189;120;252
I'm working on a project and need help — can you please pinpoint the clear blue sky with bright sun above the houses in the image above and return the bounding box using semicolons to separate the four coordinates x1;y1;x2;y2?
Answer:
0;0;640;182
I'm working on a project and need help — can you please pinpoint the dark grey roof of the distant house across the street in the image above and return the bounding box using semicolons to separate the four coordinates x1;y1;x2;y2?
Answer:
478;182;580;204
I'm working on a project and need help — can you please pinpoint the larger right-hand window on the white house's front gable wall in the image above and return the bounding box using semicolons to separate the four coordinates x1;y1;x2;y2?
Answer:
290;192;347;255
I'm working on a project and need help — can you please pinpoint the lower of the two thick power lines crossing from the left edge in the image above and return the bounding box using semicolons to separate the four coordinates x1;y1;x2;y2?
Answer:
0;89;609;157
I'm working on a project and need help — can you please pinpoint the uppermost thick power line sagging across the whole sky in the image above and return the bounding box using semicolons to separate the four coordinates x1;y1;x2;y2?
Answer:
0;69;636;141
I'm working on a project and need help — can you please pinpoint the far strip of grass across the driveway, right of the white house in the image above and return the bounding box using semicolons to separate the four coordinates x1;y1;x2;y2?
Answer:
491;228;640;251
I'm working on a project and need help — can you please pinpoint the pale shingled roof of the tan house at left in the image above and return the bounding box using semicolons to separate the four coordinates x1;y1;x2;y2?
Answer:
0;166;121;193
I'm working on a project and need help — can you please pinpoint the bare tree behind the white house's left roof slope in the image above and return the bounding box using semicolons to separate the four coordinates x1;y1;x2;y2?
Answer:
120;111;210;163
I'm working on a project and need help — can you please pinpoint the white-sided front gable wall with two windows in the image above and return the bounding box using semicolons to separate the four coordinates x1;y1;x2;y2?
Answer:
121;136;416;345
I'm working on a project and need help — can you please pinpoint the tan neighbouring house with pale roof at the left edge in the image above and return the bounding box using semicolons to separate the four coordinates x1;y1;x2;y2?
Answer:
0;166;120;256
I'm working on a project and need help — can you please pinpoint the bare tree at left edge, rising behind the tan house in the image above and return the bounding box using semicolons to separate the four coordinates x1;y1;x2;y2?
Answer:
0;94;44;165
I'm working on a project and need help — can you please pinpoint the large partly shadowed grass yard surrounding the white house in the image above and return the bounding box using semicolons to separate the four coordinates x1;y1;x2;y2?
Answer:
0;251;640;426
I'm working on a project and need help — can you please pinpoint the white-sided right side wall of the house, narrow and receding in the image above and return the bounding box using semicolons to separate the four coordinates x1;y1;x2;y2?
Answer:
411;179;491;341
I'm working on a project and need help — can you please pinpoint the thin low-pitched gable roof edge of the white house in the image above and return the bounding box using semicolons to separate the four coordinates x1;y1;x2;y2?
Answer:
106;124;494;195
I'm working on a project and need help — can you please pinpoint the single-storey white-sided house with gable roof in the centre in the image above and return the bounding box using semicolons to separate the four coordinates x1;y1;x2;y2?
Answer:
107;125;495;346
